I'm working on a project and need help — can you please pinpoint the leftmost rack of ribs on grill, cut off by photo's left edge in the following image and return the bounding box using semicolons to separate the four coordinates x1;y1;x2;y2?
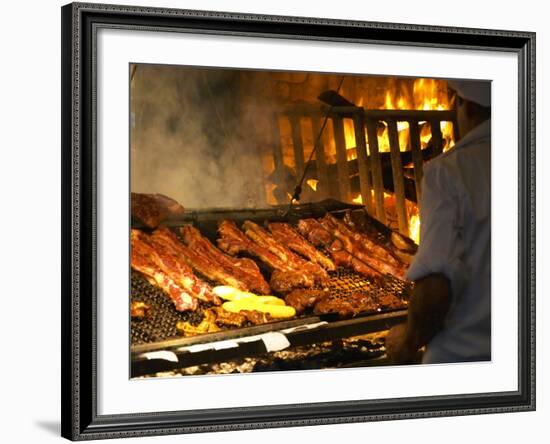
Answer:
130;230;198;311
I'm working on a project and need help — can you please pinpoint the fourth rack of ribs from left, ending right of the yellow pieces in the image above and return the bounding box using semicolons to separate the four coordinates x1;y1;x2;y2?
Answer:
180;225;270;294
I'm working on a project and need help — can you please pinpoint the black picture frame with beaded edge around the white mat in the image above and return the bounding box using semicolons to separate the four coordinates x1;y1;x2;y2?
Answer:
61;3;535;440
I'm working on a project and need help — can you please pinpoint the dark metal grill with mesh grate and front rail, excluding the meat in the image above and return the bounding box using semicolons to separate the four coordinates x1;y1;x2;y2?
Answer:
130;200;411;377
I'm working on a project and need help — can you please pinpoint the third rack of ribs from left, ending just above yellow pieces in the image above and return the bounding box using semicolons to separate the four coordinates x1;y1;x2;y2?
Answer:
152;227;247;294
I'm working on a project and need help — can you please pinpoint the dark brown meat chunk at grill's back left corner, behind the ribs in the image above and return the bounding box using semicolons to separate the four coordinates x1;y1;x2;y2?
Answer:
131;193;184;228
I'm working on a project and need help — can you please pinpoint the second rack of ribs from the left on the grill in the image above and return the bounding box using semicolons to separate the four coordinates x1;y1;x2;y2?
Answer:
131;230;221;304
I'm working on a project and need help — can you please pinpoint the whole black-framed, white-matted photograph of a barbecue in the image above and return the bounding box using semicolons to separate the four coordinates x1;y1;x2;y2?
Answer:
61;3;535;440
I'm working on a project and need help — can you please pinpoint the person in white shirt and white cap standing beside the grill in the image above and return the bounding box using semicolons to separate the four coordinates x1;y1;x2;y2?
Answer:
386;81;491;364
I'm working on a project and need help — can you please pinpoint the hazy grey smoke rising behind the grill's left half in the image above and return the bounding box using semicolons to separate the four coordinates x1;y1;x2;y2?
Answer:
131;65;273;209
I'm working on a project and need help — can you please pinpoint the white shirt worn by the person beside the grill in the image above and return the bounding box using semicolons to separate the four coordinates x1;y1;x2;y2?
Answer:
407;120;491;363
